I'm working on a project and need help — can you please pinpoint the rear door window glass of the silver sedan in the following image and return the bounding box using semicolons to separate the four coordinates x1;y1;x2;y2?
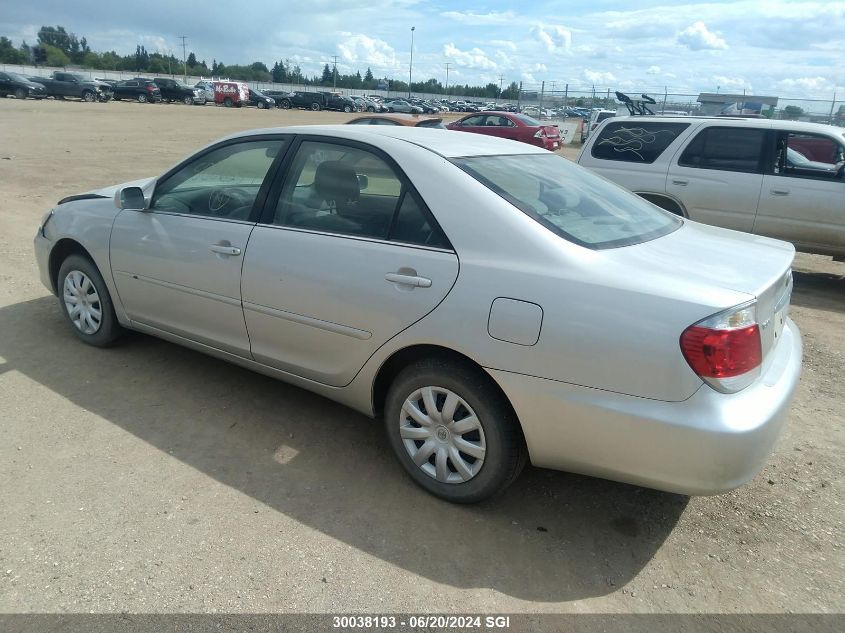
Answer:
273;141;448;246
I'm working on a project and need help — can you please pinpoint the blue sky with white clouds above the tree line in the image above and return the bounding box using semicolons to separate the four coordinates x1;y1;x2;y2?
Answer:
0;0;845;99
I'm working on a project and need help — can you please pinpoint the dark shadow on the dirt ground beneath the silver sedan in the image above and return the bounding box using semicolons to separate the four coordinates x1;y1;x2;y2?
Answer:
0;297;688;601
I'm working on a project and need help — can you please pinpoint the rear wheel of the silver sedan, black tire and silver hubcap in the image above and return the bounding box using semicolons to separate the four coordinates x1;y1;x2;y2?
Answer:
385;357;527;503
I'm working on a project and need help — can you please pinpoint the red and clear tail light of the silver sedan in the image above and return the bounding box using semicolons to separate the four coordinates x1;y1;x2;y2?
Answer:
680;301;763;393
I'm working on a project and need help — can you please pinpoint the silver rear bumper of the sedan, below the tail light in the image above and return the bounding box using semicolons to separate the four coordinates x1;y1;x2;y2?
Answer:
488;321;802;495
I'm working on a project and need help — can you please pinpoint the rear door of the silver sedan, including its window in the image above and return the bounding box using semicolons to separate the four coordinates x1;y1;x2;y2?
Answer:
242;137;458;387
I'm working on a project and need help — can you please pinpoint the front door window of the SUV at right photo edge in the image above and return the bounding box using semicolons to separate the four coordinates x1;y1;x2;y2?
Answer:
774;132;845;180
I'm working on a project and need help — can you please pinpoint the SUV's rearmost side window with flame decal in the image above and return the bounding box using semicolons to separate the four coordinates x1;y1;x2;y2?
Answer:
590;120;689;163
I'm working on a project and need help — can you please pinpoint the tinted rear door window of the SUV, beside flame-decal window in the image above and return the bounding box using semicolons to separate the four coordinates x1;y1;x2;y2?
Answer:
678;127;766;174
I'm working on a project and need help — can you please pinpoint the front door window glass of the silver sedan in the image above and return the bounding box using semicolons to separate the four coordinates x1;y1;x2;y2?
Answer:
150;139;286;220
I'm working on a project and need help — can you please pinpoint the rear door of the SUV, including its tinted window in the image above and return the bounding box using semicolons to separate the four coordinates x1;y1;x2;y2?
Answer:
666;125;768;233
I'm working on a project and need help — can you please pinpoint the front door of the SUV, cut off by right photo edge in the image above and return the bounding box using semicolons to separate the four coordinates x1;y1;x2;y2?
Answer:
754;131;845;254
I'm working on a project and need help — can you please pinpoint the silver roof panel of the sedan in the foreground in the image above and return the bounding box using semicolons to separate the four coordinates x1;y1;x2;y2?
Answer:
221;125;549;158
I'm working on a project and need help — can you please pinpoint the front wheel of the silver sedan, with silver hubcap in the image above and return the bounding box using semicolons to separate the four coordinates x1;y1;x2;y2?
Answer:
56;255;125;347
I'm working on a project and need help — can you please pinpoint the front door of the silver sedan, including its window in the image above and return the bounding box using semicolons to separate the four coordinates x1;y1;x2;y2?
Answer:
110;136;286;357
